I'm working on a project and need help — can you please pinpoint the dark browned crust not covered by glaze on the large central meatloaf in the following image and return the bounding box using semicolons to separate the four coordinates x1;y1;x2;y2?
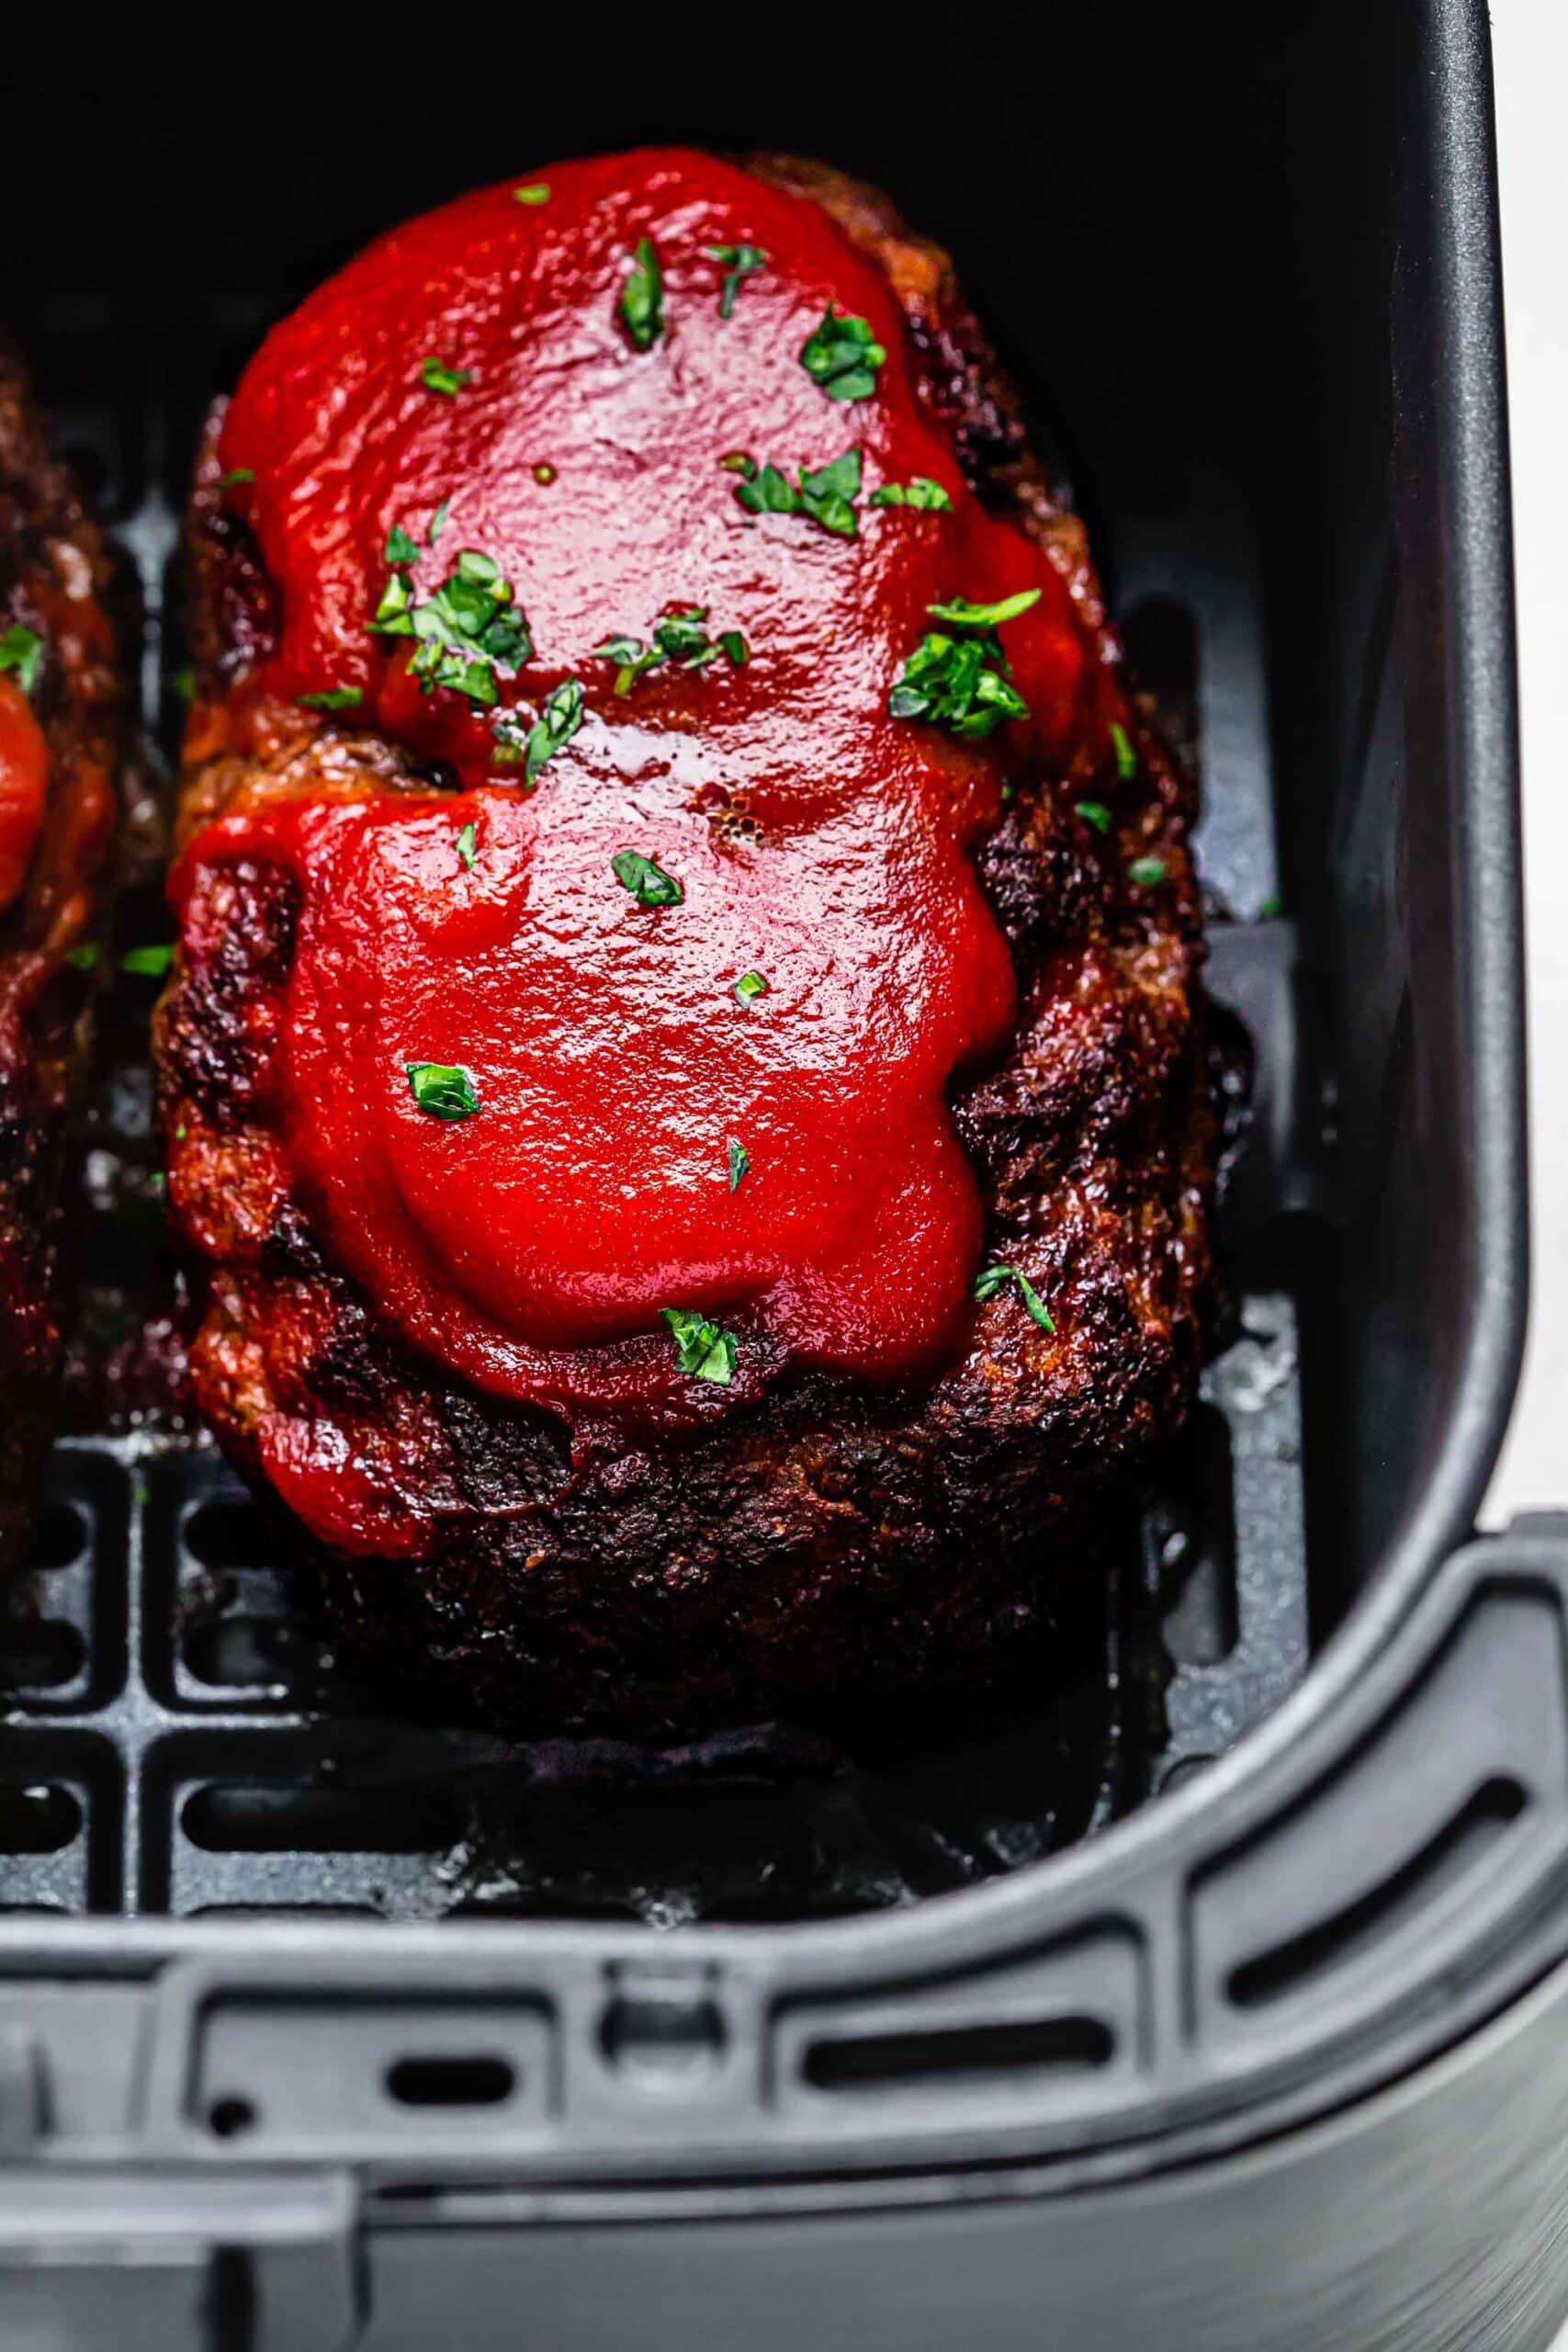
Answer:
160;158;1215;1731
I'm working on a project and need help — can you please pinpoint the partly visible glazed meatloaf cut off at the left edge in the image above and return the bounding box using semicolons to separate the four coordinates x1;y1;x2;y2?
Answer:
0;350;120;1564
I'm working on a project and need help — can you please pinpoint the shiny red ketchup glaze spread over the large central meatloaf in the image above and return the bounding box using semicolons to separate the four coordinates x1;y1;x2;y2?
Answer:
186;151;1086;1425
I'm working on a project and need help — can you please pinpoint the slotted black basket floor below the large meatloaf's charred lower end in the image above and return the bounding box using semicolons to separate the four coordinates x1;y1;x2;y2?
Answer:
0;1298;1304;1924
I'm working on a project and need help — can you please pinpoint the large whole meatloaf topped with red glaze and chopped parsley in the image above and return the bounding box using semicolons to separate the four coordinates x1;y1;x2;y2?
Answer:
157;151;1213;1734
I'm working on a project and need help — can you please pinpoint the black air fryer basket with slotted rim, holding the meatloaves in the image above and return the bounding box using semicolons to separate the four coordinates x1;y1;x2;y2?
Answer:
0;0;1568;2352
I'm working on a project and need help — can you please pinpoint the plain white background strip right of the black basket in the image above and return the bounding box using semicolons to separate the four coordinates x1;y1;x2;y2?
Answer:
1485;0;1568;1533
